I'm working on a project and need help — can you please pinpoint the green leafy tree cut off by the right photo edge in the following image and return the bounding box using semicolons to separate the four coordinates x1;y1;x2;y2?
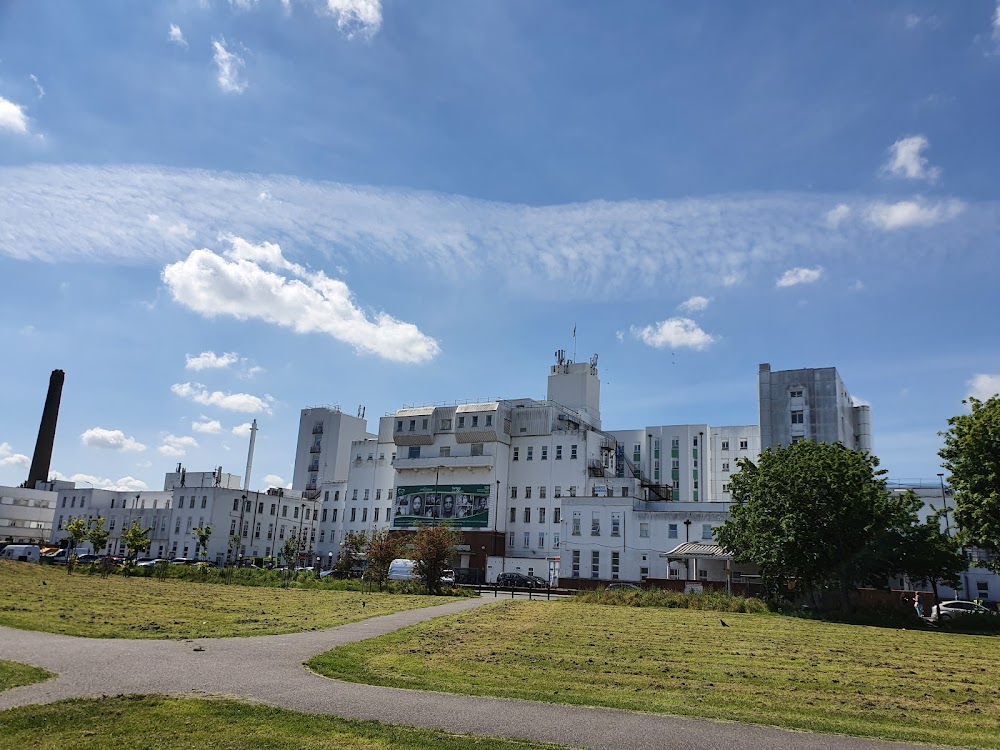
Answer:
938;395;1000;573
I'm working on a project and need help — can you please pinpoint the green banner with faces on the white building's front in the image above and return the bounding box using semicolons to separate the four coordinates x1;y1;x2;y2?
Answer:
392;484;491;529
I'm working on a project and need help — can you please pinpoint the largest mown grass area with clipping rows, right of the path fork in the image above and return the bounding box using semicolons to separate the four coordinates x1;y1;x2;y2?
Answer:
309;601;1000;748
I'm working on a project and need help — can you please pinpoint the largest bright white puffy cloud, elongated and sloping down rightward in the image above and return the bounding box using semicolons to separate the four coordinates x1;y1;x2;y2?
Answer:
163;237;440;362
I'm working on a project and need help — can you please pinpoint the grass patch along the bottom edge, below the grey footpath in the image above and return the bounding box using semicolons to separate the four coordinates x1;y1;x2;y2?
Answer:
0;696;554;750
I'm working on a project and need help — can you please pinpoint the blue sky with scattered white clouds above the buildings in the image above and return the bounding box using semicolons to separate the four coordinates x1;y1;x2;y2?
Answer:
0;0;1000;490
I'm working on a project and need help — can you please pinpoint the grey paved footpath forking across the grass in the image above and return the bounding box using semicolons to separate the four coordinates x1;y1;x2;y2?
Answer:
0;597;932;750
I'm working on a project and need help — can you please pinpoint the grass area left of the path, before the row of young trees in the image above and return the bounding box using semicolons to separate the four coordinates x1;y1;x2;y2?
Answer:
0;561;455;638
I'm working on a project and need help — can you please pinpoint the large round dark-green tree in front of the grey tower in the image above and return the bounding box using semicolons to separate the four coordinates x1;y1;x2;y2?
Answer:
716;441;909;604
